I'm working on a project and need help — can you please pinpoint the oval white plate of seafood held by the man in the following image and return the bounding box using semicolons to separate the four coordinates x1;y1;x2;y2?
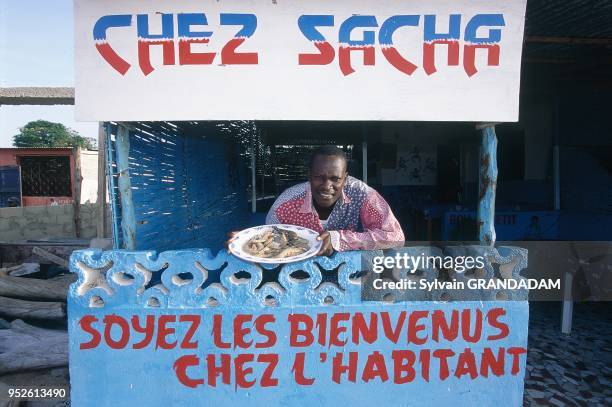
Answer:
228;225;322;264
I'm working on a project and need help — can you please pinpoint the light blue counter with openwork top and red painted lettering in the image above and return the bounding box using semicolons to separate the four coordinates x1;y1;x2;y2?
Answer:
68;248;529;406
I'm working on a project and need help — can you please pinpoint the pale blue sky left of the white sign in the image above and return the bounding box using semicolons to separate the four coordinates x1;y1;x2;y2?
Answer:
0;0;98;147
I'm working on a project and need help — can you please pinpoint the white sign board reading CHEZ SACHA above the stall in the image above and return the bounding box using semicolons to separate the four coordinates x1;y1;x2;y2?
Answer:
75;0;526;122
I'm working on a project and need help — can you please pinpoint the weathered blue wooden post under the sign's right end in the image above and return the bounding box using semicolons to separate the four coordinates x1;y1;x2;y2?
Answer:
477;124;497;246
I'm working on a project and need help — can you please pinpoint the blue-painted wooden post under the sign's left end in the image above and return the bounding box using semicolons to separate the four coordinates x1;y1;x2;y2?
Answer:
115;124;136;250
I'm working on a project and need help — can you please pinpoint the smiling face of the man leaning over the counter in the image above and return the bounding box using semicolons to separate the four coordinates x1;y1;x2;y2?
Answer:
308;155;347;208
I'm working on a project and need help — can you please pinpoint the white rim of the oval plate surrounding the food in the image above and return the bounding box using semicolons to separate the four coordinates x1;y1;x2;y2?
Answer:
229;224;323;264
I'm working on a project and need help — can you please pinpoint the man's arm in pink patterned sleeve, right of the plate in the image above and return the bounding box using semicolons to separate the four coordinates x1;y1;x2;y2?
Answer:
329;191;405;252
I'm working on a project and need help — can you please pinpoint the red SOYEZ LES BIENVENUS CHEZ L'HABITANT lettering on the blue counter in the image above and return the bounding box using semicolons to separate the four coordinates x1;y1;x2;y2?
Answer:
79;308;526;388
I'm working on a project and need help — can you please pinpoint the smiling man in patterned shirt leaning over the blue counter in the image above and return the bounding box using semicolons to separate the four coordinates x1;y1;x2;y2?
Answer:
266;146;404;256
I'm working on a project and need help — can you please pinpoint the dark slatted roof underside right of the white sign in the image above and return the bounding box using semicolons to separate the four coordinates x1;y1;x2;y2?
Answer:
522;0;612;86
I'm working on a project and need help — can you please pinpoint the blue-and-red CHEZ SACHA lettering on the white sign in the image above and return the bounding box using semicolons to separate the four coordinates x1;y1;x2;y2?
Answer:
93;13;505;76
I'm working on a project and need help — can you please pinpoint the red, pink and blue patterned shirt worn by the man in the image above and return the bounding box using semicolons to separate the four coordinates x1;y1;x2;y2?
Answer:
266;176;404;251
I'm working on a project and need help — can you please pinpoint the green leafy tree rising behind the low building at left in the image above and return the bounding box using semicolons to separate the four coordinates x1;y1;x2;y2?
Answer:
13;120;96;150
